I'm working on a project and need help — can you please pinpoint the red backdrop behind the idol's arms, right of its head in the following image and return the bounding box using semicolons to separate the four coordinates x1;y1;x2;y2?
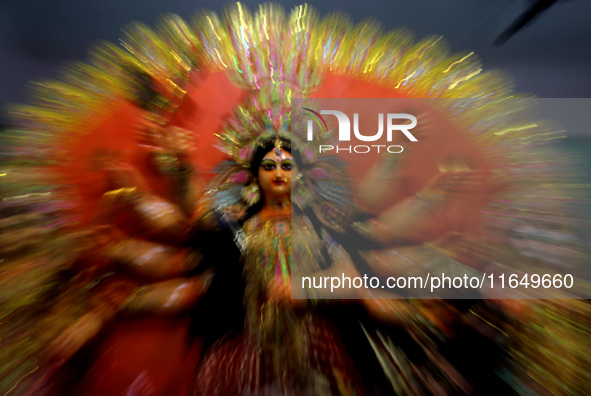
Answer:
311;74;493;240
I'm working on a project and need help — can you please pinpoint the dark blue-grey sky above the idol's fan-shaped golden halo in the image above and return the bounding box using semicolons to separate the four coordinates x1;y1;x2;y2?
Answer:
0;0;591;136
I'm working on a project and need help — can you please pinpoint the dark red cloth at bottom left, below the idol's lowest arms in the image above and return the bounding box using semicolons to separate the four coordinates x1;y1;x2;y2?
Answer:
74;318;201;396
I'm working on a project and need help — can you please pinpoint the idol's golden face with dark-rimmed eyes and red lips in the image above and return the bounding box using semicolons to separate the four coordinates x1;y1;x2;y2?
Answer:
259;149;296;200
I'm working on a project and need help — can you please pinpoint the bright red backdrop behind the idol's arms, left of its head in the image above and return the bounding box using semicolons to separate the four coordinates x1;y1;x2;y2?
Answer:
50;71;247;224
